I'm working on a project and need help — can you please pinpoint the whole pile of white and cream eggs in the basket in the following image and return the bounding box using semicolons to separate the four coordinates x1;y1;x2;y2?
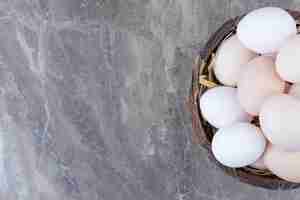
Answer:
199;7;300;183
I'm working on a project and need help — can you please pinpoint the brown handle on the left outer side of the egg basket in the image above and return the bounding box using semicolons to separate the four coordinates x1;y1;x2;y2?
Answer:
186;56;209;145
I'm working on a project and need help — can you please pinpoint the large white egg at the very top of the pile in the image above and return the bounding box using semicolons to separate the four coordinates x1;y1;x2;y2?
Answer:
237;7;297;54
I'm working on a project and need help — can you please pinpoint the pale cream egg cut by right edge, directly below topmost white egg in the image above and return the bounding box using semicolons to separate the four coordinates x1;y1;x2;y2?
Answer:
276;35;300;83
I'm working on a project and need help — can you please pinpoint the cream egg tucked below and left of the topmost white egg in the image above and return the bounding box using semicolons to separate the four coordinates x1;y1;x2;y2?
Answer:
214;35;257;86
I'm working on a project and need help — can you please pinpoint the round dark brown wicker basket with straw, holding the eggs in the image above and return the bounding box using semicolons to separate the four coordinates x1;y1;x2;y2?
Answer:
188;10;300;189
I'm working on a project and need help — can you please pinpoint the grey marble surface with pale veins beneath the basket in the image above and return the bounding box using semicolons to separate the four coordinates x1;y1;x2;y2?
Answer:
0;0;300;200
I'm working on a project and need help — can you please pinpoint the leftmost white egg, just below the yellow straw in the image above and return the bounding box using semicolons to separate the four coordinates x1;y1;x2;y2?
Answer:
200;86;251;128
